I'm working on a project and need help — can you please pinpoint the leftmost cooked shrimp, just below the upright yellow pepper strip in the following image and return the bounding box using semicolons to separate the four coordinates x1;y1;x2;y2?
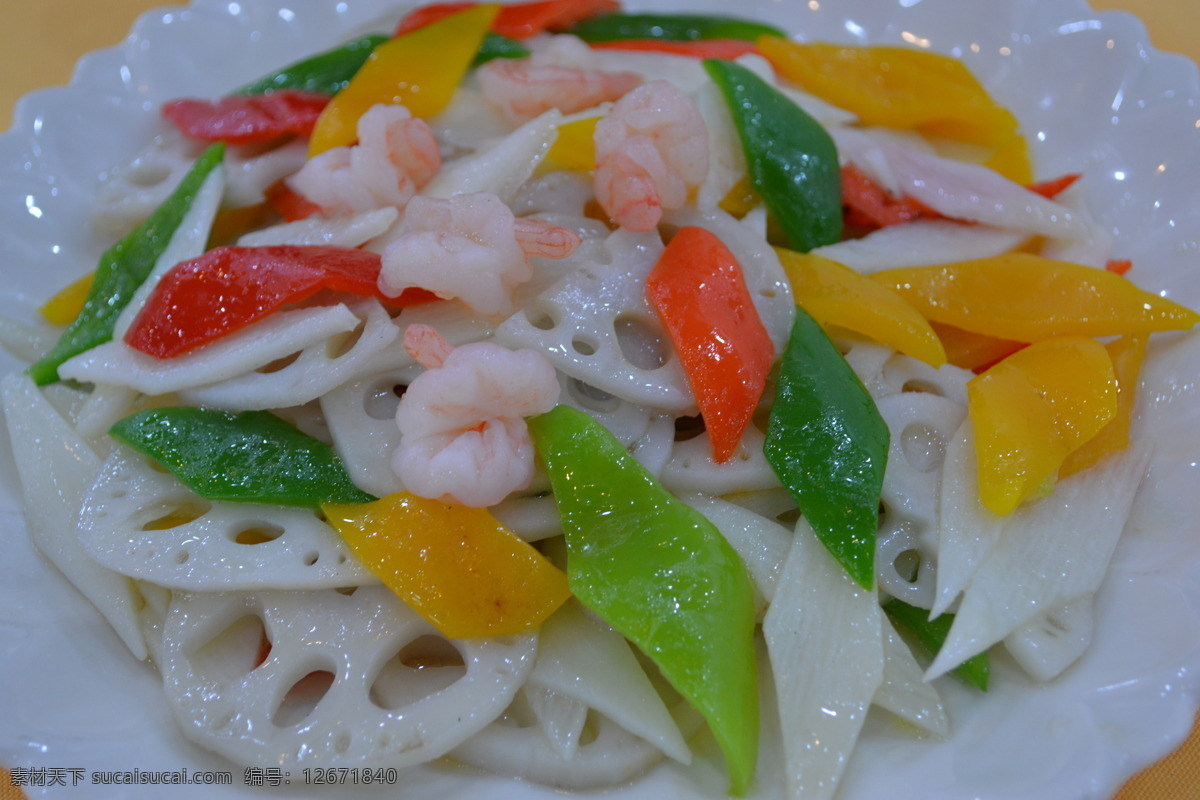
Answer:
288;104;442;215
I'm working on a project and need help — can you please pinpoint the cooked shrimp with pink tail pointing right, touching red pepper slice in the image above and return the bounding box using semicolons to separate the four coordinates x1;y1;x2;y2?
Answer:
379;192;580;314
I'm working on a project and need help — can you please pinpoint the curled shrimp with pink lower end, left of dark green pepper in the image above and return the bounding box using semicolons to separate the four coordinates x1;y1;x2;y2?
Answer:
595;80;708;230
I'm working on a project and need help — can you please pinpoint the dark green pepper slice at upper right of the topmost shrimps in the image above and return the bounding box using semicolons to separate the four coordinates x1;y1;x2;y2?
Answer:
704;59;842;253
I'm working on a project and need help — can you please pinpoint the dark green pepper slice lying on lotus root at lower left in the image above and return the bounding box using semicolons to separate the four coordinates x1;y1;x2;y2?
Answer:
109;407;378;509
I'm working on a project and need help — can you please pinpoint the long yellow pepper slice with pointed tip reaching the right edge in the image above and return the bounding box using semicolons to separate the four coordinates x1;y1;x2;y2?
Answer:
871;253;1200;342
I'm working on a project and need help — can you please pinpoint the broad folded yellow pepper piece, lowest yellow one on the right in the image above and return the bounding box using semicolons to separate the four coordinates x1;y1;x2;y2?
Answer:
967;336;1117;515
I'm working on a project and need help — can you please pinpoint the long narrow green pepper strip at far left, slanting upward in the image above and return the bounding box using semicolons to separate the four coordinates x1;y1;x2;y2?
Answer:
29;144;224;386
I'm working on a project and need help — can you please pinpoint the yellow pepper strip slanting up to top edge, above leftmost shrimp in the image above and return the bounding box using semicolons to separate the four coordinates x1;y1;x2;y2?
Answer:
308;5;500;157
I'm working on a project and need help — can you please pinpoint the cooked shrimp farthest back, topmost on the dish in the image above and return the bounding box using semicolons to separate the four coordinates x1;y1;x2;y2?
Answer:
479;54;642;125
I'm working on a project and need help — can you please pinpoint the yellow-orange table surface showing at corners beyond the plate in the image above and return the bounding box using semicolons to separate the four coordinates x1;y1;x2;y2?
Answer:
0;0;1200;800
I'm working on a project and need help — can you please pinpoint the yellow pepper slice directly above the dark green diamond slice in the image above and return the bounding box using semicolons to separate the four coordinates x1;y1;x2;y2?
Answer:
775;247;946;367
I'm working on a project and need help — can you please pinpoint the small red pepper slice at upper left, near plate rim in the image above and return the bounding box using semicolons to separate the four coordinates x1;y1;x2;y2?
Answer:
162;89;329;144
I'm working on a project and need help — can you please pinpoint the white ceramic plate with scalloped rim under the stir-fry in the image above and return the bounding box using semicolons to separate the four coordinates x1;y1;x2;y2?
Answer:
0;0;1200;800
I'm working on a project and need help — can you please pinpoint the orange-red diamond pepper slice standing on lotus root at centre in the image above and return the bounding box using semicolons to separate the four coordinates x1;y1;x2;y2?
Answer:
646;227;775;463
